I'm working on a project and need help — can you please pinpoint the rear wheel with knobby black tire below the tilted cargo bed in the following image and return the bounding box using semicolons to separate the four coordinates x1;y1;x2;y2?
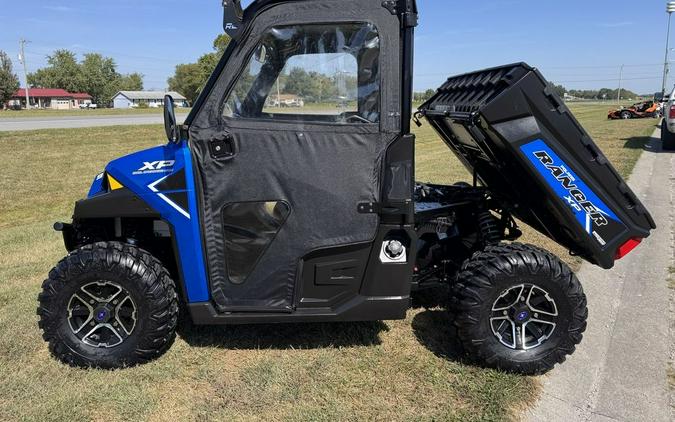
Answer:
451;243;588;375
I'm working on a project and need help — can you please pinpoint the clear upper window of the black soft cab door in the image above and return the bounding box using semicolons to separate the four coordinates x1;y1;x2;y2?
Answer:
223;23;380;124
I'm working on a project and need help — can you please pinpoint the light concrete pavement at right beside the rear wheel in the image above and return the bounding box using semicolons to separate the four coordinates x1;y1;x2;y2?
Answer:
525;130;675;422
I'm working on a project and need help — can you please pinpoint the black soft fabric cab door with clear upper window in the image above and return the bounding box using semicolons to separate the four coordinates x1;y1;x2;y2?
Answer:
190;0;400;312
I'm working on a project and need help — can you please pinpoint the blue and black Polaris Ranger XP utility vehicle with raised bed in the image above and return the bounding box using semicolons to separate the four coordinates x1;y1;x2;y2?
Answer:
38;0;655;374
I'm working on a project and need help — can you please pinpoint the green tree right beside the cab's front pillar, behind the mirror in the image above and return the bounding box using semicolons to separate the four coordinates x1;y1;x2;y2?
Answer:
167;34;230;103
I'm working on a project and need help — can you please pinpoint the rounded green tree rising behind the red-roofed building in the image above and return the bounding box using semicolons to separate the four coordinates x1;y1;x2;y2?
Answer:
28;50;82;92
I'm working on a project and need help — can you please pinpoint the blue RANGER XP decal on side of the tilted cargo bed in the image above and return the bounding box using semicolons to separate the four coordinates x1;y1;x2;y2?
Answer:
520;140;626;247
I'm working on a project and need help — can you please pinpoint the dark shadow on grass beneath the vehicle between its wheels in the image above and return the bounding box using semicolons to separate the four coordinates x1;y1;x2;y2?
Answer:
178;321;389;350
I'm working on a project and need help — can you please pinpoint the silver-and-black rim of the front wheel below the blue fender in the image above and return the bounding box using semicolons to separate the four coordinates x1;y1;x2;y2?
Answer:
67;281;137;348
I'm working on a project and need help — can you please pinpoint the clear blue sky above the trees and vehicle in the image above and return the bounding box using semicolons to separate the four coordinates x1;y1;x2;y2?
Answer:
0;0;675;94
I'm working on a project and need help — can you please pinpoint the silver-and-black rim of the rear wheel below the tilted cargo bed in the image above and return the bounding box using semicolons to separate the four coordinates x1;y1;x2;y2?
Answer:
490;284;558;350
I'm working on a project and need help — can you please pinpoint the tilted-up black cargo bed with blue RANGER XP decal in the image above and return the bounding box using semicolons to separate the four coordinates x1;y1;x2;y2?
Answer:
419;63;656;268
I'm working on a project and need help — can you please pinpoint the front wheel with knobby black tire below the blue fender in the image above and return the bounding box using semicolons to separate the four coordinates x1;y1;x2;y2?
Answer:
37;242;178;369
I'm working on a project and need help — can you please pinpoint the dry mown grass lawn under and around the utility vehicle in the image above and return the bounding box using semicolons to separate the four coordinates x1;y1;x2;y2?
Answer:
0;102;656;420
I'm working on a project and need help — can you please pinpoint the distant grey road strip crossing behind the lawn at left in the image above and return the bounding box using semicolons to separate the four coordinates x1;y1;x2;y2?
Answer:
0;114;187;132
